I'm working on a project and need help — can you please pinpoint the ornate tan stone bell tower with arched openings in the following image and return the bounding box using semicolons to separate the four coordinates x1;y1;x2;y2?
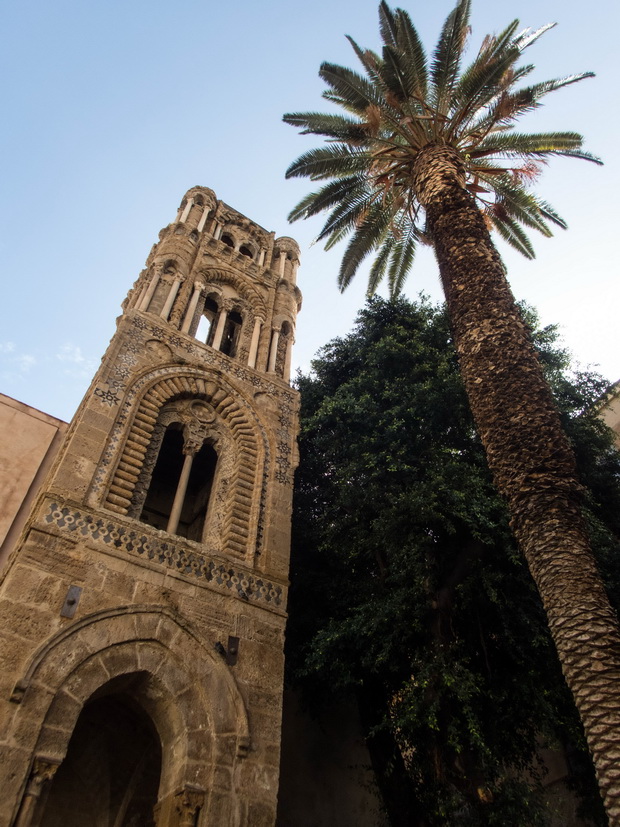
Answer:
0;187;301;827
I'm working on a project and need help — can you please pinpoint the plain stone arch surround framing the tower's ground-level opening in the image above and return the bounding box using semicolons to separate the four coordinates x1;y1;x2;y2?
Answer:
11;605;250;825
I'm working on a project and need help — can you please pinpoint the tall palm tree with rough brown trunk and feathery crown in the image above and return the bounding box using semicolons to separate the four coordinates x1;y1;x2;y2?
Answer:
284;0;620;825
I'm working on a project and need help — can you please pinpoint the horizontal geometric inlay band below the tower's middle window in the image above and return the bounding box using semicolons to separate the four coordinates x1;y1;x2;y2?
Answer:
45;503;282;606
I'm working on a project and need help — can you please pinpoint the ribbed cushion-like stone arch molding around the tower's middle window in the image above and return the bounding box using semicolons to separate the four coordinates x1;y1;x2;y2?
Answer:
89;366;269;557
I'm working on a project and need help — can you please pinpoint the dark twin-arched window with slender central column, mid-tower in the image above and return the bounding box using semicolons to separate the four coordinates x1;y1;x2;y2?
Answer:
140;422;217;542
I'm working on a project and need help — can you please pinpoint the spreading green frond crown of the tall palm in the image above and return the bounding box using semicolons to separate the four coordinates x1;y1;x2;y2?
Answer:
284;0;600;295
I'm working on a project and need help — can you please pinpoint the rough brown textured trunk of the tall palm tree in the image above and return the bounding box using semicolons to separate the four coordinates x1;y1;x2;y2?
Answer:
414;146;620;827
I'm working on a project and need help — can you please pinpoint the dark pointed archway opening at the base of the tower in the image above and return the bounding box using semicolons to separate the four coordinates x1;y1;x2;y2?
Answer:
38;676;162;827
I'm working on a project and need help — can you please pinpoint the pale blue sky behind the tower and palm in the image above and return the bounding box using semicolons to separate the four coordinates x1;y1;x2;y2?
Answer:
0;0;620;419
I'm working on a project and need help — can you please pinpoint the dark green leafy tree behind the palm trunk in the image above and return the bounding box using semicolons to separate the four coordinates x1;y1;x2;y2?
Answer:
287;299;620;827
